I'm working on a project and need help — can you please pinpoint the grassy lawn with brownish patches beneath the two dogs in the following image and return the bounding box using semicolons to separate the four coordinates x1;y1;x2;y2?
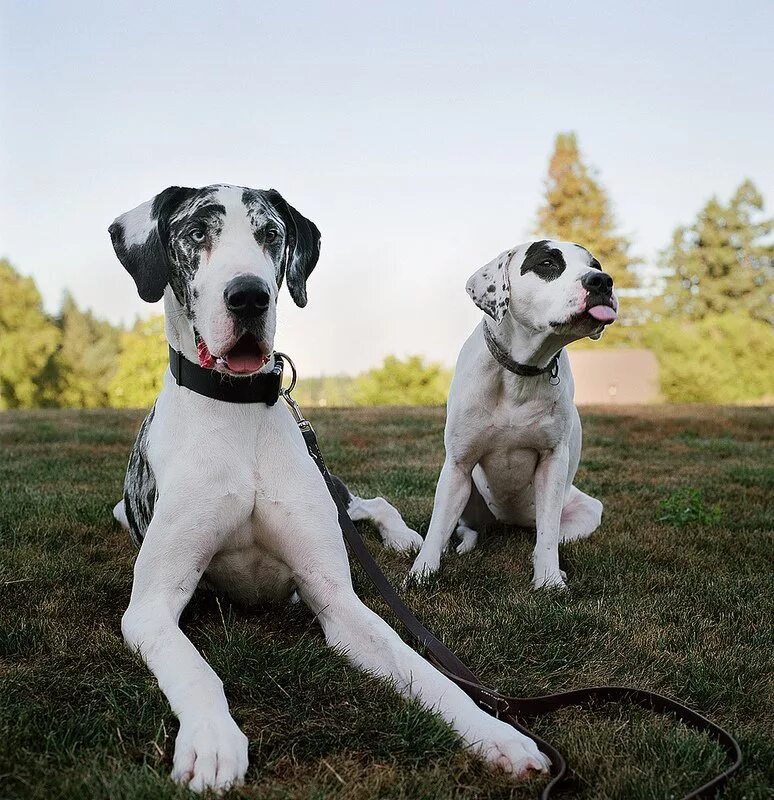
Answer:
0;407;774;800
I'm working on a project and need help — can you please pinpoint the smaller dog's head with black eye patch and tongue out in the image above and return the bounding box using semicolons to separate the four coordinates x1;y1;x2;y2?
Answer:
466;239;618;340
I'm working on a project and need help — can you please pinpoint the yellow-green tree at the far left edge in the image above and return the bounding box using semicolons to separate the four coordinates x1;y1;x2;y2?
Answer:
0;259;60;408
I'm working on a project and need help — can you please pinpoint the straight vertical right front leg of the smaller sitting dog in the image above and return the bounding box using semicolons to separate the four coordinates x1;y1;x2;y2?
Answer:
532;444;570;589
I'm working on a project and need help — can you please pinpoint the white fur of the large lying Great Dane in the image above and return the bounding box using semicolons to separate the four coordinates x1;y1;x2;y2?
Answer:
116;198;549;791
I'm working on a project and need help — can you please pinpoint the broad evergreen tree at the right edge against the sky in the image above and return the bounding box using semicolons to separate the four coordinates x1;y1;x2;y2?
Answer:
660;181;774;324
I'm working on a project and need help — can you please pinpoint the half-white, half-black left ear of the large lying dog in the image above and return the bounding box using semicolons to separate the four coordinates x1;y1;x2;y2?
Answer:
108;186;196;303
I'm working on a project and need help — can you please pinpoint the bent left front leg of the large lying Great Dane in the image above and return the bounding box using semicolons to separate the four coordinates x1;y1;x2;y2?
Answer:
121;501;247;792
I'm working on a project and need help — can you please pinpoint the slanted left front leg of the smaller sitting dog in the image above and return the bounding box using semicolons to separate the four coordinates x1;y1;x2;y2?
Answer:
410;457;473;581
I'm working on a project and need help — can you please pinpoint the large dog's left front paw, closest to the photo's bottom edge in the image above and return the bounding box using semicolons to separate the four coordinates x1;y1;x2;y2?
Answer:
172;715;247;792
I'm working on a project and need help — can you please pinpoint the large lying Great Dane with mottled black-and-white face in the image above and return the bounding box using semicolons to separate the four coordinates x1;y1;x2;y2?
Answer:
110;185;549;791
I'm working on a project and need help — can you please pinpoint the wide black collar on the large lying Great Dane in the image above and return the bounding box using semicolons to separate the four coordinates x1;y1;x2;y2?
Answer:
169;345;285;406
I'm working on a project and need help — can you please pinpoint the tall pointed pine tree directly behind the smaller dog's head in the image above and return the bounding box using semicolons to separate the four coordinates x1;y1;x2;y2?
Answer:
536;133;640;292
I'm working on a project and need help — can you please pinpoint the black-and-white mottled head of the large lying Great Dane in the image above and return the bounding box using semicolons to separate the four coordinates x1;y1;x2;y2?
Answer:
110;185;320;375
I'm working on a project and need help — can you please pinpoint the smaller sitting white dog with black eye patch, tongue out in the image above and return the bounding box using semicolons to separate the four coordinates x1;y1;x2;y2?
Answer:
411;240;618;588
